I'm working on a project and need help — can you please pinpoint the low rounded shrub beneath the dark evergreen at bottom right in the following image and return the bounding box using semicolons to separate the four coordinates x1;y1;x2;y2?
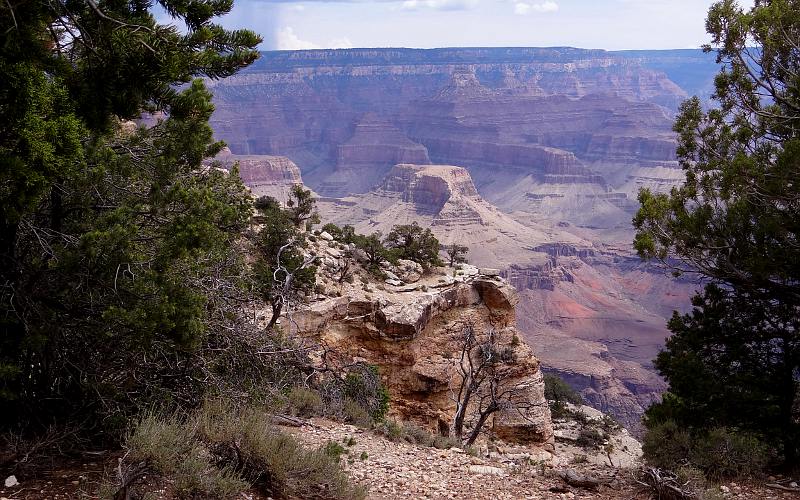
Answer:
690;427;770;481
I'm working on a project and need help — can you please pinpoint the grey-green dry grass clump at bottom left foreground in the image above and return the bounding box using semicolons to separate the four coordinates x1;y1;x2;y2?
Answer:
103;400;365;500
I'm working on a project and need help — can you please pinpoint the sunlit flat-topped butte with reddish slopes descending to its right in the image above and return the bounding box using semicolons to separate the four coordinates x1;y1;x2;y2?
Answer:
312;165;694;432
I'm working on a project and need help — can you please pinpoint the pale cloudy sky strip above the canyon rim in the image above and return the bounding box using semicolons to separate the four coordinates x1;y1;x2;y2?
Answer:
177;0;752;50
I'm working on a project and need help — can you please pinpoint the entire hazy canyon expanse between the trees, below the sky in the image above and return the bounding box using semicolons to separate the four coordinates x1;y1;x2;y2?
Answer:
209;48;717;430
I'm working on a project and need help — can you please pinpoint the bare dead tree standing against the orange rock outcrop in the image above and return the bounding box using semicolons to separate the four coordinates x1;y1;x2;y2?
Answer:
450;323;524;446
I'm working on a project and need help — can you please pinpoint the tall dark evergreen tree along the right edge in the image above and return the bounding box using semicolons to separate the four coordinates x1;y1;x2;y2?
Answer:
634;0;800;467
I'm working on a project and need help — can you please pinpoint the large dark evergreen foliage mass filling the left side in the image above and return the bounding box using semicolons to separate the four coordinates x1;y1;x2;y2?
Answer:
0;0;260;438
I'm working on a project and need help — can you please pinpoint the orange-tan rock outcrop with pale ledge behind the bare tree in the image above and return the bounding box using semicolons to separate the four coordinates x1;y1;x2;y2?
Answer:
289;240;553;446
